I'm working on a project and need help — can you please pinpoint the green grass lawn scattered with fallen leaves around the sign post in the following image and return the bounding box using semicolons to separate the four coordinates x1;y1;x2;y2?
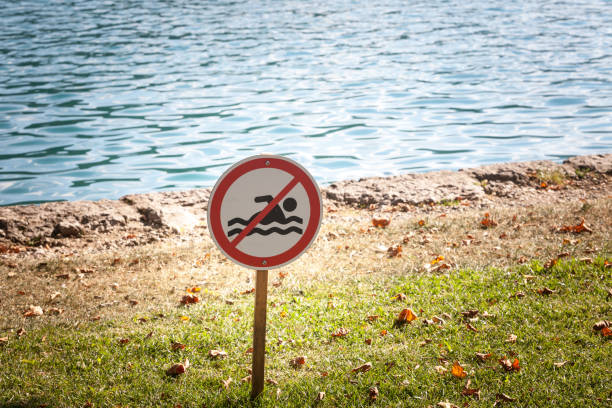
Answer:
0;257;612;407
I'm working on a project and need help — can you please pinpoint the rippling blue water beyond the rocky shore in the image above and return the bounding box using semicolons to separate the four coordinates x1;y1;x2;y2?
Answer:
0;0;612;204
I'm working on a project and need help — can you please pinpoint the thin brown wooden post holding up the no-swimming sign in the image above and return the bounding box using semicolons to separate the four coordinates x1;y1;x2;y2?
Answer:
251;270;268;400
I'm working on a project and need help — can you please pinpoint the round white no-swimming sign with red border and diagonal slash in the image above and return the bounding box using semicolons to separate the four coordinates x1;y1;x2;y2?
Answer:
208;155;323;269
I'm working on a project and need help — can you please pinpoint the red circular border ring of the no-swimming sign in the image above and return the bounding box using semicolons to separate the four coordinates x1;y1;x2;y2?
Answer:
207;155;322;269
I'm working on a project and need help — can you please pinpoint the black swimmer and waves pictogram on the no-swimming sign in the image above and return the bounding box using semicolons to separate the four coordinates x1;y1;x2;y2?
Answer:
227;195;304;237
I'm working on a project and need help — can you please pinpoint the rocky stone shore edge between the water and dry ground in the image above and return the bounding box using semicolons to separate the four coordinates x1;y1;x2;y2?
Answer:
0;154;612;249
